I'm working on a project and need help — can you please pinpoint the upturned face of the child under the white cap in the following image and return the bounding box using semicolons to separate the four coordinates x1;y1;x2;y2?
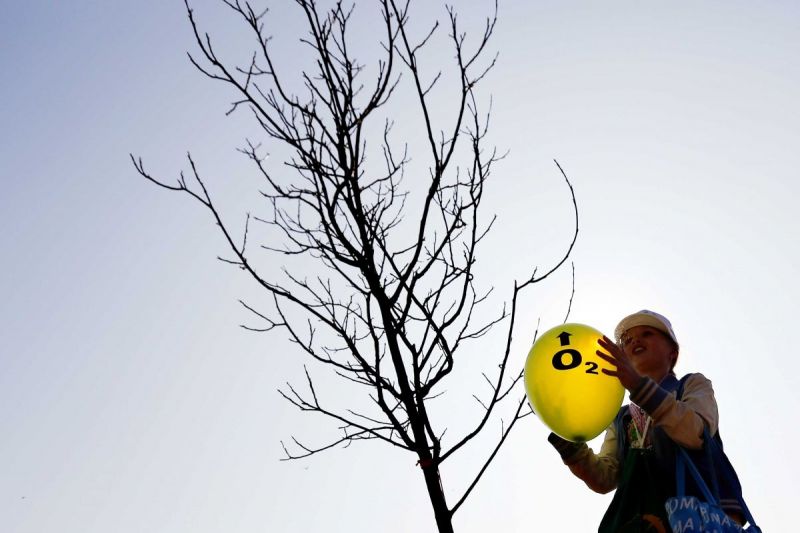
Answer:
620;326;678;382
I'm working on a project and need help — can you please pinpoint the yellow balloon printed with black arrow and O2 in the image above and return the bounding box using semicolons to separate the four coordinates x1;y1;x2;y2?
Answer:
525;324;625;442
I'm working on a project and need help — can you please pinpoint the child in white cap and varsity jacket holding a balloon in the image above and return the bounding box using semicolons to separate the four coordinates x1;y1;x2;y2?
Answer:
548;310;744;533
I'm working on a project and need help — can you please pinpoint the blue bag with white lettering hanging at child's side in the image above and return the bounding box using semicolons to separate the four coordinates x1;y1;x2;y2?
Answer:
664;429;761;533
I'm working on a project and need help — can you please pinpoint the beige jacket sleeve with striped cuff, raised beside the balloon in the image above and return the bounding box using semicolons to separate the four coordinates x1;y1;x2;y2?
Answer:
631;374;719;450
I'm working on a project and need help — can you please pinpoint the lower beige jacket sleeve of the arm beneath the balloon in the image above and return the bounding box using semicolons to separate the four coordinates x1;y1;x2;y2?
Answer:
548;424;619;494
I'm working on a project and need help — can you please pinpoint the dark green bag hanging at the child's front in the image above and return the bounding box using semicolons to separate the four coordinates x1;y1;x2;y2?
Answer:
598;448;669;533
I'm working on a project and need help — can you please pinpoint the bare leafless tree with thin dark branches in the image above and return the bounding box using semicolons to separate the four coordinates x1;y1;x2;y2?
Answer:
131;0;578;532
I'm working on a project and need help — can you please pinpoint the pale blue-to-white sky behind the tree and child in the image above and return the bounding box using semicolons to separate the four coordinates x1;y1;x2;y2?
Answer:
0;0;800;533
